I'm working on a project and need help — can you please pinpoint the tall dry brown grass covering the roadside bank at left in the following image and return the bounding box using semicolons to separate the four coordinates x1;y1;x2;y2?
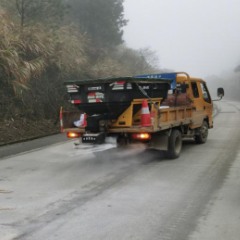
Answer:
0;10;87;95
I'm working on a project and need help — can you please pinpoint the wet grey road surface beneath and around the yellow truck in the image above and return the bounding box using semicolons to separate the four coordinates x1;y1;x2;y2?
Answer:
0;101;240;240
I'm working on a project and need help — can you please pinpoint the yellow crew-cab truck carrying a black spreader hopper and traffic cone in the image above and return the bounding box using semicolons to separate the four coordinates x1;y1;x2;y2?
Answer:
60;72;224;159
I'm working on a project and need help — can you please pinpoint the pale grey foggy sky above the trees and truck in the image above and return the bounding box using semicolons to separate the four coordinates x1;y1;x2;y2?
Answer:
124;0;240;77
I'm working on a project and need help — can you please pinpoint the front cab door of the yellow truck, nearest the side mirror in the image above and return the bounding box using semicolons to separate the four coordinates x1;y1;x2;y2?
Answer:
200;82;213;127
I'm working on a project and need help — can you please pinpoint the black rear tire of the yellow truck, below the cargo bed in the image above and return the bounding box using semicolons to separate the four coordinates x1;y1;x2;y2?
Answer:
167;129;182;159
